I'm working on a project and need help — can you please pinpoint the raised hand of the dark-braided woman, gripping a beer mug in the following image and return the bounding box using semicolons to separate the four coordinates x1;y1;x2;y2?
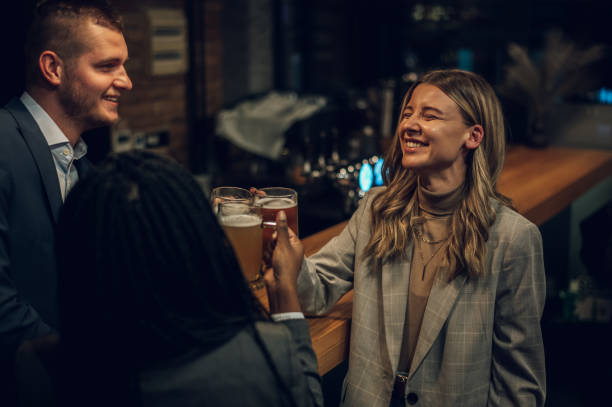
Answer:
264;211;304;314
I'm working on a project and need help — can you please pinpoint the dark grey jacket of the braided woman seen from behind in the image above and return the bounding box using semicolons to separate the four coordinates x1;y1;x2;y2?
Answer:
141;319;323;407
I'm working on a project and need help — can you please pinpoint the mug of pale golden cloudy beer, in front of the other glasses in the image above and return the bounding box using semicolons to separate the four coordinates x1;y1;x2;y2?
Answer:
217;201;263;289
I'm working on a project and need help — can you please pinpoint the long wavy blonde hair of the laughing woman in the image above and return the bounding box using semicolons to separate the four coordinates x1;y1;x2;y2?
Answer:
364;69;511;279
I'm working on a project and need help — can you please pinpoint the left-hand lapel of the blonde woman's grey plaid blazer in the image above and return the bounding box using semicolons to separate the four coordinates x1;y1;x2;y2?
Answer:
381;243;412;371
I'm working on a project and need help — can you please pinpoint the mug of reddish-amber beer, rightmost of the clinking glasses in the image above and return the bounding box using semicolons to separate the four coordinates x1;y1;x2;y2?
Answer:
254;187;298;258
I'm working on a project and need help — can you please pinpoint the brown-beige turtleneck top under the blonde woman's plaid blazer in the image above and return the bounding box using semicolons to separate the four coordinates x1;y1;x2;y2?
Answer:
398;183;463;372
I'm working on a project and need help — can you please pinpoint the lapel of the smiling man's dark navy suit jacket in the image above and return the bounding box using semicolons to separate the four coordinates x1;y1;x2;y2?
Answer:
6;98;62;221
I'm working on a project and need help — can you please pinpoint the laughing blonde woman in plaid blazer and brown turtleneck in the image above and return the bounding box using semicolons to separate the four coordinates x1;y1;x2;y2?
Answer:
272;70;546;407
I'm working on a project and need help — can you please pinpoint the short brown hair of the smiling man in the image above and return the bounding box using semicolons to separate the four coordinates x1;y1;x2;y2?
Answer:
25;0;123;84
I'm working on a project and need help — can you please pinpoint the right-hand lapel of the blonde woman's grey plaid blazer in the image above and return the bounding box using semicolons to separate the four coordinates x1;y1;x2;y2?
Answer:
408;267;466;378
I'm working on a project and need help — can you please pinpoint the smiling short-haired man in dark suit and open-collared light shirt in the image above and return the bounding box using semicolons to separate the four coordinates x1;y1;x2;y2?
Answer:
0;0;132;396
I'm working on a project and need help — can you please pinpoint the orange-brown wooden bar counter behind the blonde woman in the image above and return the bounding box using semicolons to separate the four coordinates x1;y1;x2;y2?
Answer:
272;146;612;375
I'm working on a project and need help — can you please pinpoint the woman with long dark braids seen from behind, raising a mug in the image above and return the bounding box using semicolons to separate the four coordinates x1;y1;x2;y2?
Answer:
51;152;322;406
